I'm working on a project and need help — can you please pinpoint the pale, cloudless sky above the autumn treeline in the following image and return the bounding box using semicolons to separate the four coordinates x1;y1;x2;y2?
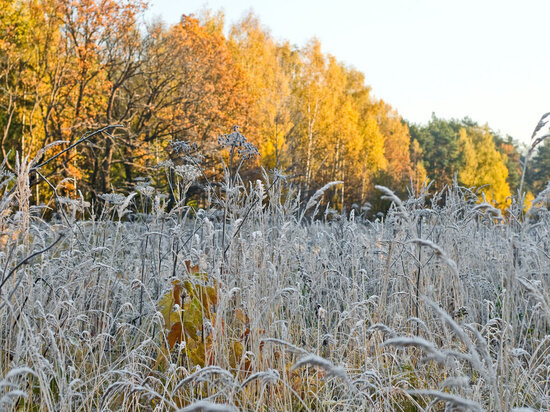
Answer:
149;0;550;142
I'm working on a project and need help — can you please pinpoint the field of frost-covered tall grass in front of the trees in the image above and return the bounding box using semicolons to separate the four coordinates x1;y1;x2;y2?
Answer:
0;159;550;411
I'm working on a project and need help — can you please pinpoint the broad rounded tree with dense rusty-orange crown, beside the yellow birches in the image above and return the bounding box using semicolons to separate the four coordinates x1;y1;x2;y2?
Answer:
130;15;251;193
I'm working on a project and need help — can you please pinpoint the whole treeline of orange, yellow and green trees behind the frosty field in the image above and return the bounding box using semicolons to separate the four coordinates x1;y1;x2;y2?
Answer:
0;0;550;207
